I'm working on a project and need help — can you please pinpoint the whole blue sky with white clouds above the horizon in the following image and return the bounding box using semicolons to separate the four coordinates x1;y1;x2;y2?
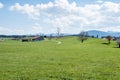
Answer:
0;0;120;35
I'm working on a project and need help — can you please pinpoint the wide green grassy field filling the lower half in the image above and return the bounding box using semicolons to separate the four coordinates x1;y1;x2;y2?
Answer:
0;37;120;80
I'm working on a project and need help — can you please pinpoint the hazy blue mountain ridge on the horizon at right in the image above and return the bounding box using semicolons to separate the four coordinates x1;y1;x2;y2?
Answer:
87;30;120;38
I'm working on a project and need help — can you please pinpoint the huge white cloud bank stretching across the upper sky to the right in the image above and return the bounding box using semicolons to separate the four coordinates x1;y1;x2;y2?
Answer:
10;0;120;32
